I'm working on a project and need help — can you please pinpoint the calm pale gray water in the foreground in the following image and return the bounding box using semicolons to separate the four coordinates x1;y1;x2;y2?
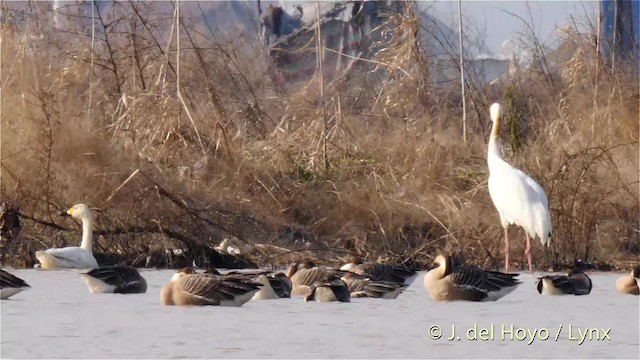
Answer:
0;269;640;359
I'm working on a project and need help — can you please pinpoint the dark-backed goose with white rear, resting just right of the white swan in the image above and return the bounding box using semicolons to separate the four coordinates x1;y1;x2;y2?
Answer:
80;265;147;294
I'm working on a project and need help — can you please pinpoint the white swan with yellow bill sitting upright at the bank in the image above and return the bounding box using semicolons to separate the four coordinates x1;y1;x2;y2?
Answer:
36;204;98;269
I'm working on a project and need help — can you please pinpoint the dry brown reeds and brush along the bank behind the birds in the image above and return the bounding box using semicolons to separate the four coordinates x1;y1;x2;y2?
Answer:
0;2;640;267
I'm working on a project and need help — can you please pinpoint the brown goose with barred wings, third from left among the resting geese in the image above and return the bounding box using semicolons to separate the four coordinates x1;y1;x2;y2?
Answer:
160;267;262;306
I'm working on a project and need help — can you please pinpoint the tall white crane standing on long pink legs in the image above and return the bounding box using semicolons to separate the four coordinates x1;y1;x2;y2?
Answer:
487;103;551;273
